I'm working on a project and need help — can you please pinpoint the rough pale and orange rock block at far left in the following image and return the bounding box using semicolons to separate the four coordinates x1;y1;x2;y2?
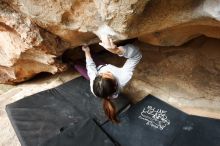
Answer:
0;1;69;83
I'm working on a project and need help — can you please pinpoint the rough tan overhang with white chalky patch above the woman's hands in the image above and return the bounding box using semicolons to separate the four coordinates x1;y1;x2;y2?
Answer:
5;0;150;46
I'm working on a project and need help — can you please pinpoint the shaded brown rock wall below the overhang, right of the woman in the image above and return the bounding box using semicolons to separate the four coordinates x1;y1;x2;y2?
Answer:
132;37;220;115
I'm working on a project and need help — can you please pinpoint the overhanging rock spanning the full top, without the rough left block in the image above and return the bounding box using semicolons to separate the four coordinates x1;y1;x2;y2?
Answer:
5;0;220;46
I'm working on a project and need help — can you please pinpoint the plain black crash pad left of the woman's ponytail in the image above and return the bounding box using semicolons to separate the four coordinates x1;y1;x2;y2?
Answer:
6;77;129;146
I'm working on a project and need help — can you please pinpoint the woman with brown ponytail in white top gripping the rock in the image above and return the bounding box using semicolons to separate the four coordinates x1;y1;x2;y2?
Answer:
82;36;142;123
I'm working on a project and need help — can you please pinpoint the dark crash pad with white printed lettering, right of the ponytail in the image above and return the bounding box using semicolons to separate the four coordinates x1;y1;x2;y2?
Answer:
102;95;220;146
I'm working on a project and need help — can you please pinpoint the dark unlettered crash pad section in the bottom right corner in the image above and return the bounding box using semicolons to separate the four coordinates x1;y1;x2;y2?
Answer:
171;116;220;146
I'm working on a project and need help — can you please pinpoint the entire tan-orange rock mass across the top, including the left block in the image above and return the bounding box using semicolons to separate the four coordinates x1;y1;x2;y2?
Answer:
0;0;220;83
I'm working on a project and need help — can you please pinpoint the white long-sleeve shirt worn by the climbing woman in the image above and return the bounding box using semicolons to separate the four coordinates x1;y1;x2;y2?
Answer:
86;44;142;98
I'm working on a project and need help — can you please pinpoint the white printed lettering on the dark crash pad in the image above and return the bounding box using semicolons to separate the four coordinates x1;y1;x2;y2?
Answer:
138;106;170;130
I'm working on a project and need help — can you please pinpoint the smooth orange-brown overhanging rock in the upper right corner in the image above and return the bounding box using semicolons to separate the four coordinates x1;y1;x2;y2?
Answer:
138;0;220;46
